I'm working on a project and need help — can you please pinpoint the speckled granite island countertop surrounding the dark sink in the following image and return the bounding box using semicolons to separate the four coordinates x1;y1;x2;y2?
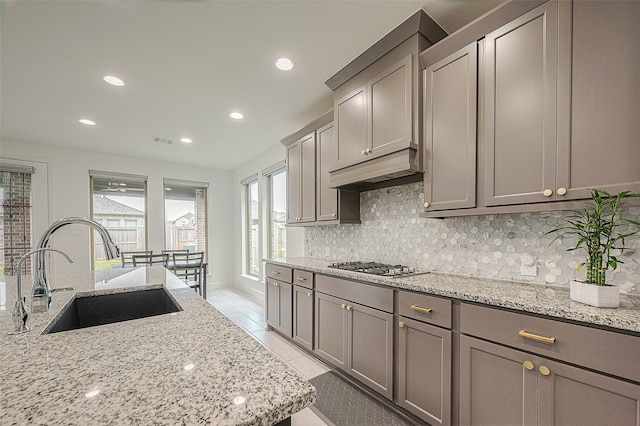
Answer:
0;266;316;425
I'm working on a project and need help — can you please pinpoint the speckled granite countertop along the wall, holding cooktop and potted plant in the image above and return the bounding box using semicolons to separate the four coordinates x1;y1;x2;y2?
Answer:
266;257;640;333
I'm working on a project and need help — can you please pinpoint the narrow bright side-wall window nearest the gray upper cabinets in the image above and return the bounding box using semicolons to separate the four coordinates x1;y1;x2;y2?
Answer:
262;161;287;258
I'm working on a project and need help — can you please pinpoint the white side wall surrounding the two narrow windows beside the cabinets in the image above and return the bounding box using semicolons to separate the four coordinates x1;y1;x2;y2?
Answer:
232;142;304;298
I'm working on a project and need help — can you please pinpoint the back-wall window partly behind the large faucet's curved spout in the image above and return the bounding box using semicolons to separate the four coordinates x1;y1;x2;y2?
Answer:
89;171;147;269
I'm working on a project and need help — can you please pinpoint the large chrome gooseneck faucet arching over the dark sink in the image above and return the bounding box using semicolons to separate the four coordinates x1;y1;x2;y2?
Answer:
31;217;120;306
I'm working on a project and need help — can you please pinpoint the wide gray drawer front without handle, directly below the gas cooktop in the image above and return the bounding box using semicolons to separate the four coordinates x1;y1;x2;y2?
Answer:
316;274;393;313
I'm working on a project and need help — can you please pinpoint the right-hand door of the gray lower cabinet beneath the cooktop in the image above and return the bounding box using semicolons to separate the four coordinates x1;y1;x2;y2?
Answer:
346;302;393;399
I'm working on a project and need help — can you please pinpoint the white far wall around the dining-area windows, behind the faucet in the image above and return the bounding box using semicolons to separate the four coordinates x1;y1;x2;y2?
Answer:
0;140;235;286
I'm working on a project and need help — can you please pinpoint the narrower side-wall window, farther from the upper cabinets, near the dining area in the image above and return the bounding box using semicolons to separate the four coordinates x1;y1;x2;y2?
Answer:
242;174;260;277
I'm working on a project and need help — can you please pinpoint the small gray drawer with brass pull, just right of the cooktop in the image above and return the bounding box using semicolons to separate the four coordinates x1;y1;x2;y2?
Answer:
398;291;451;328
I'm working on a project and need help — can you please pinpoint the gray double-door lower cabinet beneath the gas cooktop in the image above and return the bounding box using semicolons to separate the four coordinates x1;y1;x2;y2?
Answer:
315;290;393;399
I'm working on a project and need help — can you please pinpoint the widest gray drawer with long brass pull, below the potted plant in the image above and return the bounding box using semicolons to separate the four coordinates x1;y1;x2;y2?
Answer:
460;303;640;382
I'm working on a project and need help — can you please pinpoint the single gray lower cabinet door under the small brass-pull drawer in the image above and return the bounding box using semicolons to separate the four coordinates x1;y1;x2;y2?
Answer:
396;317;451;425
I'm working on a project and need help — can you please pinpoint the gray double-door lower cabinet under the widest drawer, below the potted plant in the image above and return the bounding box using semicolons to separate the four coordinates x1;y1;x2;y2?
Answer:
460;335;640;426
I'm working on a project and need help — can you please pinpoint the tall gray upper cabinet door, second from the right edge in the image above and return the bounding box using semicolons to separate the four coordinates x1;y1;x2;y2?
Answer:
482;2;558;206
